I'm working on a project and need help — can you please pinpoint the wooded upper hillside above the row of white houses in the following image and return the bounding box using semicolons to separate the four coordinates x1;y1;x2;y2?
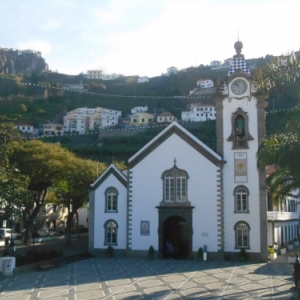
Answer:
0;56;293;127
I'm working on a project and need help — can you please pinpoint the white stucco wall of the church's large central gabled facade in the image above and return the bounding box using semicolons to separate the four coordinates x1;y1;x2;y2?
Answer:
132;134;218;251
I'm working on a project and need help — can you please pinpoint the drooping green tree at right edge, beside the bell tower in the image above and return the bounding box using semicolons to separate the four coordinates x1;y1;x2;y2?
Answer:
258;107;300;206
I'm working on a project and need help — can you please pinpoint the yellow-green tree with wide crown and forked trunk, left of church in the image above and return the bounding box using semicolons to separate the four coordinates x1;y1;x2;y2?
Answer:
10;140;73;242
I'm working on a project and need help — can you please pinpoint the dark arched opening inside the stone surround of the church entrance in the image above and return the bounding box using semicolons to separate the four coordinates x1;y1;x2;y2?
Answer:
162;216;189;259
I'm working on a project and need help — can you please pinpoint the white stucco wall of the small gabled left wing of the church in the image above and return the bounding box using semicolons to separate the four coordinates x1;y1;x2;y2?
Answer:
94;174;127;249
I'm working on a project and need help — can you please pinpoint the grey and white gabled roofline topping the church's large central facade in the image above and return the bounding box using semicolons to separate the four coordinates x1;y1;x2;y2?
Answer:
128;121;224;168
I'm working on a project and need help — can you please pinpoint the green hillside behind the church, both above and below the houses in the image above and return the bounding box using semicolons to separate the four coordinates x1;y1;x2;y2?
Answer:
0;51;299;162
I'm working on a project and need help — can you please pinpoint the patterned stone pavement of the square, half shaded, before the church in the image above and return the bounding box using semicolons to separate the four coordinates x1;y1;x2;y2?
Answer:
0;258;298;300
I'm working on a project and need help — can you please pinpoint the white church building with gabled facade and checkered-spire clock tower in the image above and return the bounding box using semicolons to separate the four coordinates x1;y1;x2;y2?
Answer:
89;41;268;261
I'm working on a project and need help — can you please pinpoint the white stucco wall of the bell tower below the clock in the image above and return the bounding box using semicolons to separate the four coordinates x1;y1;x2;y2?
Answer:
223;97;261;252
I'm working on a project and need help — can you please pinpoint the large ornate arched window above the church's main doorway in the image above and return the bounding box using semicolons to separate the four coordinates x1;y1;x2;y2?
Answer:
162;161;188;203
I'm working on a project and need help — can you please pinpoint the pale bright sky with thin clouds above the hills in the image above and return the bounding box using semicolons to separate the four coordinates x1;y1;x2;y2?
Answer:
0;0;300;77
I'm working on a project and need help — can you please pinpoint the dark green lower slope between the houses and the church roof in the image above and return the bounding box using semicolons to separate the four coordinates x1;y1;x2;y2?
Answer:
37;111;287;163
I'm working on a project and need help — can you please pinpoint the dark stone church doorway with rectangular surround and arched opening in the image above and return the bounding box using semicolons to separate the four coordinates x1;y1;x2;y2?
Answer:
157;206;194;259
